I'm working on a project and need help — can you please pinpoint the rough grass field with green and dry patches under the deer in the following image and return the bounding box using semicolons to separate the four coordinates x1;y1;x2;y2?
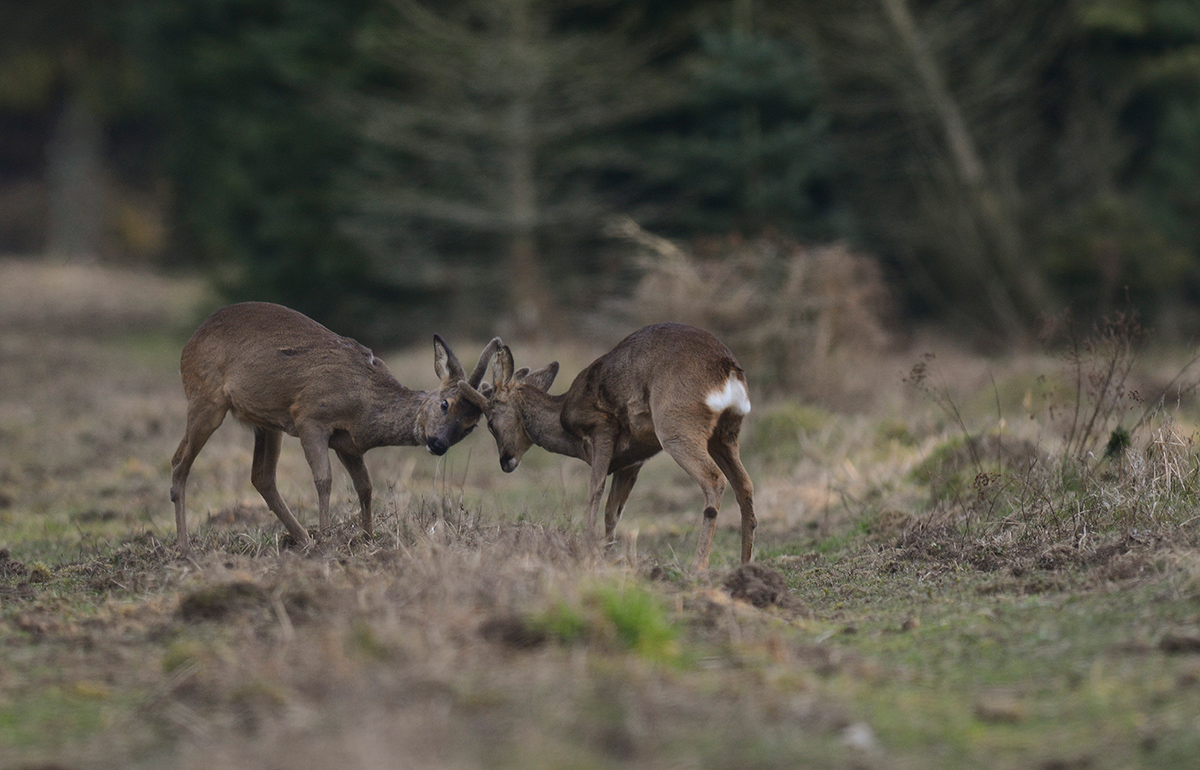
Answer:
0;263;1200;770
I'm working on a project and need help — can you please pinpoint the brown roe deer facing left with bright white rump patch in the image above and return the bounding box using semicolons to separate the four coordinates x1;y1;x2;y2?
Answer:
485;324;757;570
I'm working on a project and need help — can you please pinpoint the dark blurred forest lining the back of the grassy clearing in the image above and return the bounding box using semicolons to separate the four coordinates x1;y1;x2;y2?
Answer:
0;0;1200;347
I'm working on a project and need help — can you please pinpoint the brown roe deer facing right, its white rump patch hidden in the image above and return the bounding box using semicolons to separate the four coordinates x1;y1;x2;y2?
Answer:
170;302;502;551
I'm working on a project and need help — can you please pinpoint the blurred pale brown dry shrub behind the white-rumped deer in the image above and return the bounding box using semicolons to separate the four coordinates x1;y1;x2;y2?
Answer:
611;219;892;397
